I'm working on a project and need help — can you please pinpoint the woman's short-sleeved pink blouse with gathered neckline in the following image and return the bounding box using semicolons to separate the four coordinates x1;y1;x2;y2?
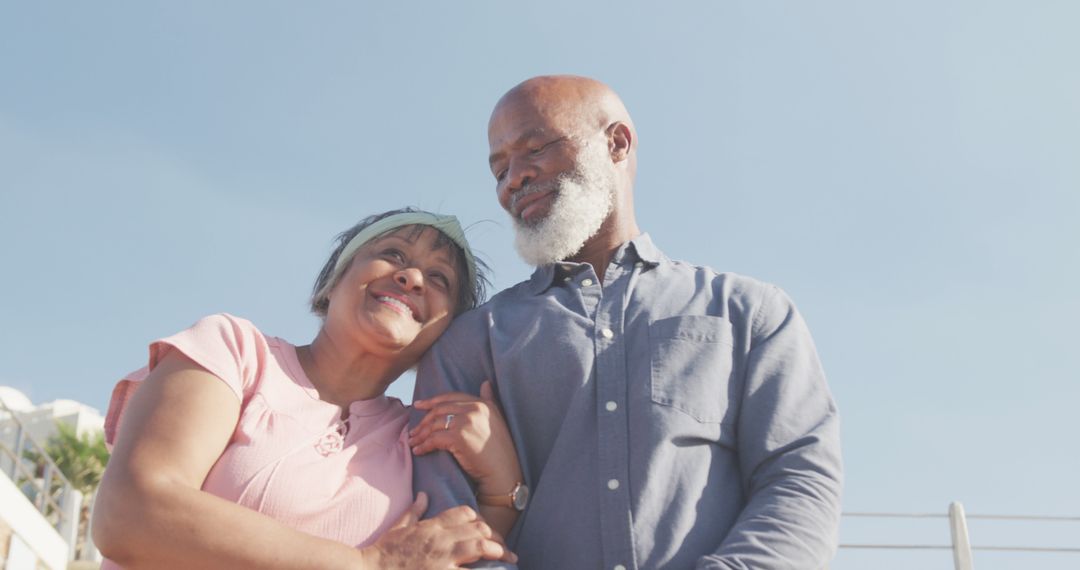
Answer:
105;314;413;568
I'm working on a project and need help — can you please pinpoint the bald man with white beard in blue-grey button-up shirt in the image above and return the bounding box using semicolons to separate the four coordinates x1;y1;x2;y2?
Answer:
414;77;841;570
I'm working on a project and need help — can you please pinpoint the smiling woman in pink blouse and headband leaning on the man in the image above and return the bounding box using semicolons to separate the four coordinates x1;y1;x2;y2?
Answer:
94;209;522;569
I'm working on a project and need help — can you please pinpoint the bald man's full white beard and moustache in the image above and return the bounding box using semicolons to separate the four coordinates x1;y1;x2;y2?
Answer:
513;145;615;266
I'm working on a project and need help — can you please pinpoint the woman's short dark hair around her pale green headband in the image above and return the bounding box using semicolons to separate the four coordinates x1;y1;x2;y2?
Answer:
311;207;490;317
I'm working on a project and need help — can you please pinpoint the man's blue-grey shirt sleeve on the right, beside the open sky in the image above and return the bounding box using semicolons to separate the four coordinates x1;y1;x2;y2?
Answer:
698;287;842;570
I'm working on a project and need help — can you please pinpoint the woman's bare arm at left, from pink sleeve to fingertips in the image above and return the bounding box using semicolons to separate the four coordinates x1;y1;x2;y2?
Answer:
93;350;504;569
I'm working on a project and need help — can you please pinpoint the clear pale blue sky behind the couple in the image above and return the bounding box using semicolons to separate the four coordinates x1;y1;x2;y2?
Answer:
0;0;1080;570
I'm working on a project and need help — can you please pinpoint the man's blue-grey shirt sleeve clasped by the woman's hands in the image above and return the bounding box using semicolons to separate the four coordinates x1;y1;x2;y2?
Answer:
409;311;517;570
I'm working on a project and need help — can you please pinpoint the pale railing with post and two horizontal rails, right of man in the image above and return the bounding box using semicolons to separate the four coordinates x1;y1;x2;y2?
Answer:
839;502;1080;570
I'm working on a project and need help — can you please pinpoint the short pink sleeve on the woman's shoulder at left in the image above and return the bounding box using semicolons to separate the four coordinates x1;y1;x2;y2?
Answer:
105;313;270;447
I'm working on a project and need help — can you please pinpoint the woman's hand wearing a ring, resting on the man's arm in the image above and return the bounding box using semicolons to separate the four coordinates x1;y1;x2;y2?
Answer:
409;381;523;494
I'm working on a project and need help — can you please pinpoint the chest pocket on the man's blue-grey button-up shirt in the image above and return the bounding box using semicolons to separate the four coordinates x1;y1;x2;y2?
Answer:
649;315;732;423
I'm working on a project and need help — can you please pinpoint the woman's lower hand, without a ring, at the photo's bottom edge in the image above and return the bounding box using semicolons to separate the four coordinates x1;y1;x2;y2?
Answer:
361;492;517;570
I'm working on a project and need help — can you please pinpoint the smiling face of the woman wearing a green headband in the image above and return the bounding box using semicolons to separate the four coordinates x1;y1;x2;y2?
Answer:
324;226;461;366
